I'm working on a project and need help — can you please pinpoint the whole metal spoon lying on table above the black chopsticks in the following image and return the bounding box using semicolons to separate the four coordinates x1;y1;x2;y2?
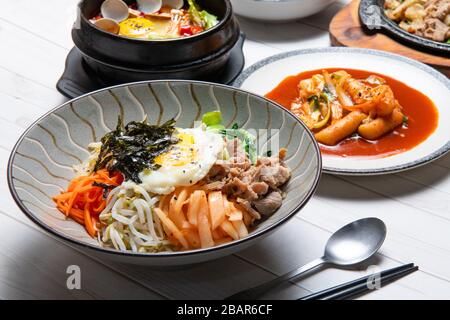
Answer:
226;218;386;300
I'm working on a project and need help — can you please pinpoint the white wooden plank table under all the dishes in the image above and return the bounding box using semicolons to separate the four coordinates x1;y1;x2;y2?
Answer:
0;0;450;299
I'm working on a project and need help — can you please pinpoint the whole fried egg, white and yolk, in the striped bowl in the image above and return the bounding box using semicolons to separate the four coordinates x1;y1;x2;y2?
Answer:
139;128;225;194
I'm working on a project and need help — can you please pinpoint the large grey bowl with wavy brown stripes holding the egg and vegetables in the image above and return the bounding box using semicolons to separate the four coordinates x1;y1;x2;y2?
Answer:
8;81;322;266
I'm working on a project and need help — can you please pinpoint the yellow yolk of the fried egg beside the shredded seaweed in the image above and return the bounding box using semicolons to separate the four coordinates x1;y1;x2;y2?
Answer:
155;133;197;167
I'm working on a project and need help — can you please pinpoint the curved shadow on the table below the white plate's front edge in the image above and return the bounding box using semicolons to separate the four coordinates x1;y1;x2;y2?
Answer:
316;154;450;201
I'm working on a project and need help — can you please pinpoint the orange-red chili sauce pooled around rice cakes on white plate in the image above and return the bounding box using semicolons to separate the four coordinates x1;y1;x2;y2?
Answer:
266;68;439;158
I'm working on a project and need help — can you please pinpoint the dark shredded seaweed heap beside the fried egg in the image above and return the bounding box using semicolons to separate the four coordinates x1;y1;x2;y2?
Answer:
94;117;178;183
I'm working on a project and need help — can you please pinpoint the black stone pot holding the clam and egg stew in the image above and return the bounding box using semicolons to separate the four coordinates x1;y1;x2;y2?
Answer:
72;0;240;70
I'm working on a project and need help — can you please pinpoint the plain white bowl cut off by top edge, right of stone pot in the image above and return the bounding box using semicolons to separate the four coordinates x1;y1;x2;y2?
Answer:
231;0;336;22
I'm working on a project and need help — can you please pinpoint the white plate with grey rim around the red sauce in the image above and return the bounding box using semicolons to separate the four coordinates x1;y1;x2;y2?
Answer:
234;48;450;175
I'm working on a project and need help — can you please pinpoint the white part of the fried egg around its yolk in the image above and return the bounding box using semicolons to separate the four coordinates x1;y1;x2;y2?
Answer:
139;128;225;194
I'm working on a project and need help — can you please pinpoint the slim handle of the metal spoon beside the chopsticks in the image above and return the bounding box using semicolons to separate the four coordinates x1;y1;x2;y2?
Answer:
225;258;326;300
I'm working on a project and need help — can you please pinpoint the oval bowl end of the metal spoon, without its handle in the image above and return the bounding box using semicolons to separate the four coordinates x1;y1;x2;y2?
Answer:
323;218;387;267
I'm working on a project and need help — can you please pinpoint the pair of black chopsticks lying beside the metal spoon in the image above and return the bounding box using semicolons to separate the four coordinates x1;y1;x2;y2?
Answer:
298;263;419;300
